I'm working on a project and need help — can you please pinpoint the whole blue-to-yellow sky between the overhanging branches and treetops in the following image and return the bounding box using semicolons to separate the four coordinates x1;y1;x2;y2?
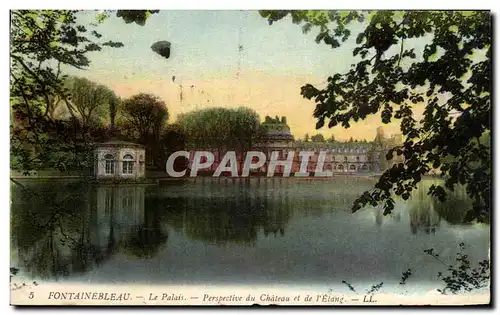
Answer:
65;10;423;140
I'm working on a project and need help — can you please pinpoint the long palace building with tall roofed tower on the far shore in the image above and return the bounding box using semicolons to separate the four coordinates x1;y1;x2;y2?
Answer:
188;117;401;176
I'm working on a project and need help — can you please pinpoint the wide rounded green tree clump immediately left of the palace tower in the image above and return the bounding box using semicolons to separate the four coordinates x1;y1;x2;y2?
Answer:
178;107;260;150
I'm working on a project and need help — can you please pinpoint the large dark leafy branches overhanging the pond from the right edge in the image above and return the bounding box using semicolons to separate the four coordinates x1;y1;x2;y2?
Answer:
260;11;492;221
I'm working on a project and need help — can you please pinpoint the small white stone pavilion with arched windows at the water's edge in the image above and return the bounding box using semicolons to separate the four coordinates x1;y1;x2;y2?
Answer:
94;141;145;179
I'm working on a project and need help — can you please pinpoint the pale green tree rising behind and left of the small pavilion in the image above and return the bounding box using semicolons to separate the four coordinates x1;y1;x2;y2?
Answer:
67;77;116;127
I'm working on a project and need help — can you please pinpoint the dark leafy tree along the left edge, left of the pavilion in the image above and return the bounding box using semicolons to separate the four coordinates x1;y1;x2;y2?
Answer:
10;10;123;171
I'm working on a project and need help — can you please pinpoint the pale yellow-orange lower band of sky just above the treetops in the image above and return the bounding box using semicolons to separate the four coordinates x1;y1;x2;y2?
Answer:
87;70;406;140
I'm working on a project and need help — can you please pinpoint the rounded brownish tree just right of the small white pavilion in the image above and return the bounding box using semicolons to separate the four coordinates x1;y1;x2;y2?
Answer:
122;93;168;141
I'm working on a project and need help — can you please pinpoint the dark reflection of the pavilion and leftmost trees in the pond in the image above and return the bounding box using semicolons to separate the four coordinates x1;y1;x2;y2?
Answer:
12;185;167;279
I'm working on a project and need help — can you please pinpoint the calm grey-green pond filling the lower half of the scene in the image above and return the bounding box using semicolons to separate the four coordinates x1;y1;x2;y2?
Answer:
11;178;490;292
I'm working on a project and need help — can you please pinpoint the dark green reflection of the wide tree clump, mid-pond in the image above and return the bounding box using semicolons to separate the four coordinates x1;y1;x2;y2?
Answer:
158;178;291;245
